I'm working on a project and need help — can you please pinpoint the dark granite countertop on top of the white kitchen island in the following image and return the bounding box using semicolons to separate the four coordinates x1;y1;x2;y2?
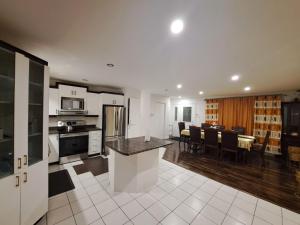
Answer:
105;137;173;156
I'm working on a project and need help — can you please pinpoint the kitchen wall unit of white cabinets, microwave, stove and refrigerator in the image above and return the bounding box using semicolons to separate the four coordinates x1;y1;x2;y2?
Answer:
48;82;126;164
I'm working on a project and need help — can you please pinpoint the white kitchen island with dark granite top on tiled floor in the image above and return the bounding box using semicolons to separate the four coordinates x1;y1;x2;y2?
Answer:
105;137;172;192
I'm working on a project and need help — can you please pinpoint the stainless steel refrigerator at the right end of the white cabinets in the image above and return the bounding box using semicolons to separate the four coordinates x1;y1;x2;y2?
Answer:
102;105;126;154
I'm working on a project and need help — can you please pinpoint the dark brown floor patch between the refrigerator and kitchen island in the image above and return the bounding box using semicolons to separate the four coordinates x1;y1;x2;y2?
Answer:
73;156;108;176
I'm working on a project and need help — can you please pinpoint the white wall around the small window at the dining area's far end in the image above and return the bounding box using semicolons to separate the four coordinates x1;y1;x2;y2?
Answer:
169;98;205;137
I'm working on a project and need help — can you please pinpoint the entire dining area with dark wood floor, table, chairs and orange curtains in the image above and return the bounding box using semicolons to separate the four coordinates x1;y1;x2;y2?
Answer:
163;95;300;212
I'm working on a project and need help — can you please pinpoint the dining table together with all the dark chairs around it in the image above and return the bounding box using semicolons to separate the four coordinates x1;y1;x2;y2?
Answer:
178;122;271;166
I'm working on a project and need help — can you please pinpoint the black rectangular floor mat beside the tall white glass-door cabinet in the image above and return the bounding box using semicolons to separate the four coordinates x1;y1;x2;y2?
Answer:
49;170;75;197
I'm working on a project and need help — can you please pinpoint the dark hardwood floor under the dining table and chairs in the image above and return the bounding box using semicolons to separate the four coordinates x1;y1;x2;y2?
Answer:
163;141;300;213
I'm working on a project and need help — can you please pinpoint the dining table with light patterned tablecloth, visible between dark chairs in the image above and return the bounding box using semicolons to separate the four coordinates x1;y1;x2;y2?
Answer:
181;129;255;151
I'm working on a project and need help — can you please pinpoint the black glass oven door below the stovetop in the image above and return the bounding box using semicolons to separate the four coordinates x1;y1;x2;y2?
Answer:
59;132;89;157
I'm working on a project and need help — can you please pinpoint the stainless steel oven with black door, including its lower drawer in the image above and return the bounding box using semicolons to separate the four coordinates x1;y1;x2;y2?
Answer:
59;132;89;163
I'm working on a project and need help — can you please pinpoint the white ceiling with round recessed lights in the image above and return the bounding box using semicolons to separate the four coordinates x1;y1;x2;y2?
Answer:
0;0;300;97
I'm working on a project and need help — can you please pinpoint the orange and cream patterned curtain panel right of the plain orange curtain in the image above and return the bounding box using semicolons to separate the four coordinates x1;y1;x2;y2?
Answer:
253;96;282;154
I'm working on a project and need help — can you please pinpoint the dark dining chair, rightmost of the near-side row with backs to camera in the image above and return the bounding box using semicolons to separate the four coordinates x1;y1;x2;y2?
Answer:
221;130;240;162
